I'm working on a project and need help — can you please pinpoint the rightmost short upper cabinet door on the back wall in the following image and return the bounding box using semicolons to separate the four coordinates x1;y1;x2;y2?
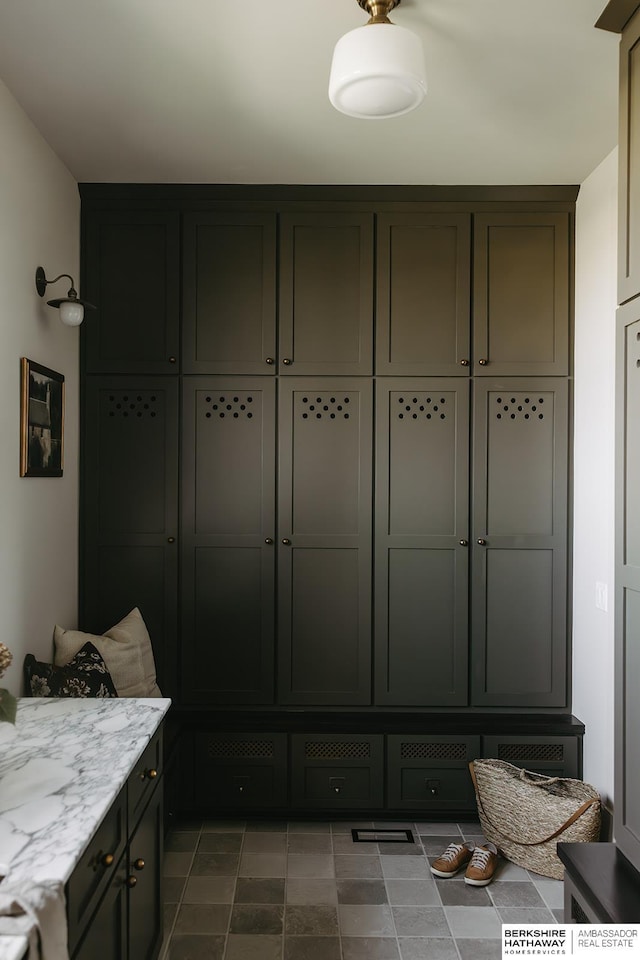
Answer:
473;212;570;376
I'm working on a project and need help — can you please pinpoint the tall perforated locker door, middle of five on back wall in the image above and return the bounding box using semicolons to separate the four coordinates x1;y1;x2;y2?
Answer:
278;378;372;704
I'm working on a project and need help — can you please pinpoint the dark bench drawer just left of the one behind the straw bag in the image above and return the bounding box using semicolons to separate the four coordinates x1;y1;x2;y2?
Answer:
387;734;480;810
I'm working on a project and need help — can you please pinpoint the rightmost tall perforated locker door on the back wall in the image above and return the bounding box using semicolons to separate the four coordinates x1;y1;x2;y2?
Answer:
472;378;568;707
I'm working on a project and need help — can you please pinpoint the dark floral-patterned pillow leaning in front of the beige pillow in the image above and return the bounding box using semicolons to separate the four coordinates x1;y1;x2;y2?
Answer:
24;643;118;697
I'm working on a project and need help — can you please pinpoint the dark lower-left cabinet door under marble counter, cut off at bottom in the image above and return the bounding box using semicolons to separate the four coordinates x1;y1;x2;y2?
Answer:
72;854;128;960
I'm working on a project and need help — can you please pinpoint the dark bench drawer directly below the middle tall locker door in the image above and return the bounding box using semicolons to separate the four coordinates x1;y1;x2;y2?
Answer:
291;734;384;809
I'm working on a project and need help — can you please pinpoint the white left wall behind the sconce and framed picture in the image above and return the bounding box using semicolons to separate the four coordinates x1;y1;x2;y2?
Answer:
0;82;80;694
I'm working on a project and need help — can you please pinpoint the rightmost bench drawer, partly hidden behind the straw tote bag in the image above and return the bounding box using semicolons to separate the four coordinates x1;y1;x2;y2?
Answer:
482;735;582;779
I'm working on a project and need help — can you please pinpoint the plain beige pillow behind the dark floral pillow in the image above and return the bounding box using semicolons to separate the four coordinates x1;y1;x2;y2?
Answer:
53;607;162;697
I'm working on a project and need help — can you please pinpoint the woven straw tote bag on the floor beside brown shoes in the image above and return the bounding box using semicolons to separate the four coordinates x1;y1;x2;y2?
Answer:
469;760;600;880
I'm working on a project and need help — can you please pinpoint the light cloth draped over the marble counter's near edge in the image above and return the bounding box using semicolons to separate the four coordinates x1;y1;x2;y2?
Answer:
0;878;69;960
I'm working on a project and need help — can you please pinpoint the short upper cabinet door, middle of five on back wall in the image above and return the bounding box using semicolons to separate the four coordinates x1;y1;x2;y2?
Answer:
280;211;373;376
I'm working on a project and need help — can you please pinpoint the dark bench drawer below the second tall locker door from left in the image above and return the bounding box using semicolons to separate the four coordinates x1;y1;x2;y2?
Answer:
194;733;287;809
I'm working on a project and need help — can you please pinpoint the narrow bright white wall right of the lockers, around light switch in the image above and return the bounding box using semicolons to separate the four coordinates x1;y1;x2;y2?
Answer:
573;150;618;807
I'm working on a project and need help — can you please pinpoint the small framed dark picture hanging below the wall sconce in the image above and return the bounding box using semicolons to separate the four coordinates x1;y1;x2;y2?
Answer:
20;357;64;477
